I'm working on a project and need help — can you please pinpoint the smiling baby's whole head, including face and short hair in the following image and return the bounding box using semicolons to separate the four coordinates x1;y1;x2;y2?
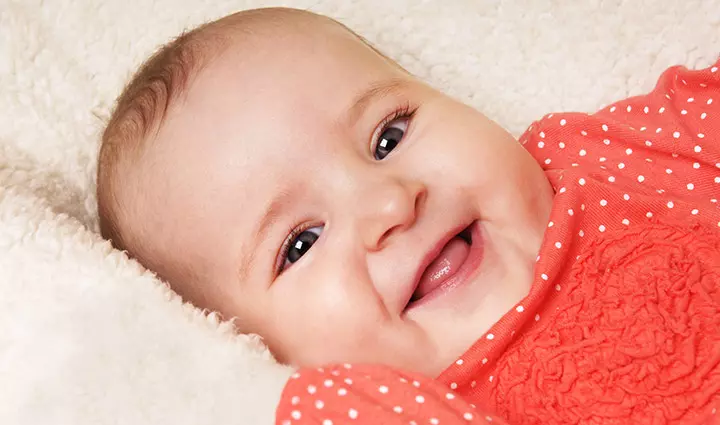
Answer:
98;9;552;375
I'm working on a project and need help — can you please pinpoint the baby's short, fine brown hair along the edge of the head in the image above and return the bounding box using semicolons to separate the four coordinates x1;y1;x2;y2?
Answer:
97;8;402;255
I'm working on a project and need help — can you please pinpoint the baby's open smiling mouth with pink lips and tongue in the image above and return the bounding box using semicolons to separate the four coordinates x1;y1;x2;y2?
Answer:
406;221;482;308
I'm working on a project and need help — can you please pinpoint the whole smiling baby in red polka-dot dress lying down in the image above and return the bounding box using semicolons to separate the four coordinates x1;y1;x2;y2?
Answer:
98;9;720;425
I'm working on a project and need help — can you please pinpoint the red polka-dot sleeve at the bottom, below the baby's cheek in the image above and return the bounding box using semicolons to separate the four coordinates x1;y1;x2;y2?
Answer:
275;364;506;425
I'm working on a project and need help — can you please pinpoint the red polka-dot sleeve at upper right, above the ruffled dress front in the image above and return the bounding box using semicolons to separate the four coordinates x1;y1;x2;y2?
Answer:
521;57;720;205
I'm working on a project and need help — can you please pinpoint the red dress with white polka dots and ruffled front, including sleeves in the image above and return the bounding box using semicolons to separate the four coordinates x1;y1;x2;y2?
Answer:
277;62;720;425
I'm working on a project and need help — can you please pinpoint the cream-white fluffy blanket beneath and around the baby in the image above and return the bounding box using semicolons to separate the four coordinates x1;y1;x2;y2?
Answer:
0;0;720;425
